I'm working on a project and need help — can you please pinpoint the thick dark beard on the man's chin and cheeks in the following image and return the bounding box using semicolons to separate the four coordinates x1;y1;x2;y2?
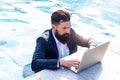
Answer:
55;30;70;44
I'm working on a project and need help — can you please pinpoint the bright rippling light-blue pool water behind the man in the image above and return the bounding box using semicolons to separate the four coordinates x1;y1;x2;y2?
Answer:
0;0;120;80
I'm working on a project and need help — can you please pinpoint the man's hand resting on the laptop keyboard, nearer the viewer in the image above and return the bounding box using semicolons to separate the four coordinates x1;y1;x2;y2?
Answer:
59;58;80;69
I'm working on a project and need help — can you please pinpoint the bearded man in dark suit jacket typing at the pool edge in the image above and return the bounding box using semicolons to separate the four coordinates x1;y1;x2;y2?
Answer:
31;10;96;72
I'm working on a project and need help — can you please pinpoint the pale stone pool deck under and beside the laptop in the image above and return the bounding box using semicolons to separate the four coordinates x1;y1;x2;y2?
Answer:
24;36;120;80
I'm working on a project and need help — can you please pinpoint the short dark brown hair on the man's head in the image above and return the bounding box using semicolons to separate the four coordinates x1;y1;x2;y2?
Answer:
51;10;70;25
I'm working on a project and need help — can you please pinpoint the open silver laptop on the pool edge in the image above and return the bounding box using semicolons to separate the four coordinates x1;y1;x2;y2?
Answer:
63;41;110;73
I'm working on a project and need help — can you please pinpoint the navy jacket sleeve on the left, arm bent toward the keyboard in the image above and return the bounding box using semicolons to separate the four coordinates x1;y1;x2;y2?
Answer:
31;37;58;72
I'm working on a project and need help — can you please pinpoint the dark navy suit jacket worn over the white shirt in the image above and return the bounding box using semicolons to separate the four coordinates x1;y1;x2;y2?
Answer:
31;29;95;72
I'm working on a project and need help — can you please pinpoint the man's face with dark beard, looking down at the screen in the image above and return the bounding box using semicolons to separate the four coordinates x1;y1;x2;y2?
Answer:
55;21;71;44
